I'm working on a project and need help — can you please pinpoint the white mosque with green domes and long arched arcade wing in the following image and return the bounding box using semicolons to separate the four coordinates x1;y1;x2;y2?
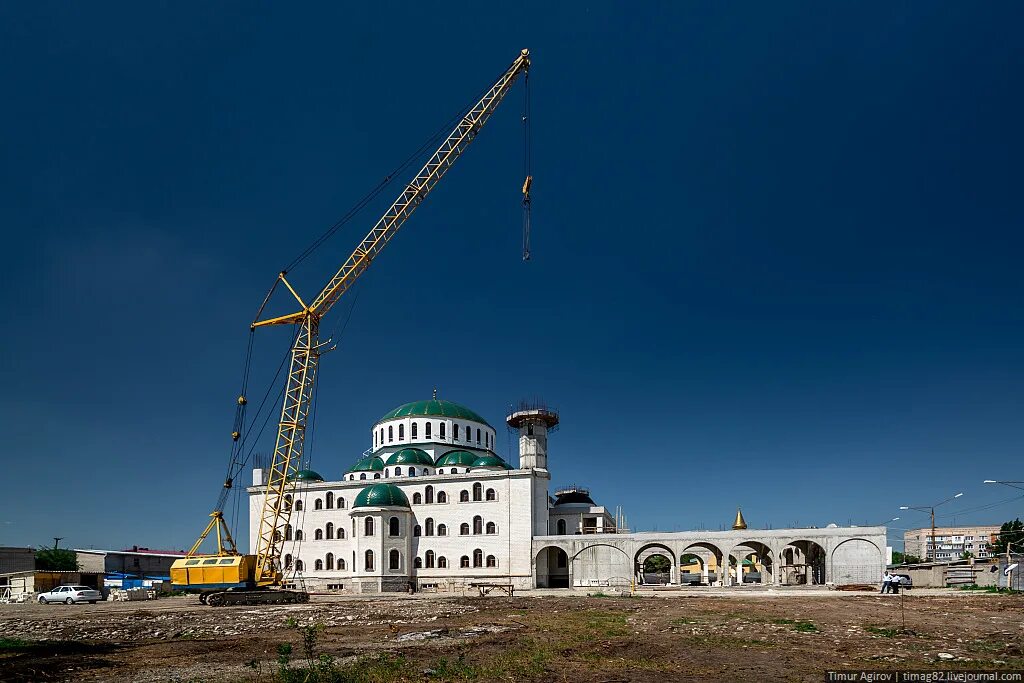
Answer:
248;397;885;593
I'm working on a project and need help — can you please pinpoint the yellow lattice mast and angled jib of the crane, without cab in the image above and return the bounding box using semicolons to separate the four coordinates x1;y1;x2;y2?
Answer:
245;50;529;586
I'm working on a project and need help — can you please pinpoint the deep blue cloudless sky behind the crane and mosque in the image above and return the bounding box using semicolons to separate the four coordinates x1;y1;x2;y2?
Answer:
0;2;1024;547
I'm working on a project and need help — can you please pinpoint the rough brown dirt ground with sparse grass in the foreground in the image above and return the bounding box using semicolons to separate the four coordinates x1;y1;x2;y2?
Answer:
0;592;1024;683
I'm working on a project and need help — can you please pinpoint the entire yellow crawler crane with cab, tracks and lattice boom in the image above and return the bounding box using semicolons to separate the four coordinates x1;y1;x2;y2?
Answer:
171;50;531;605
